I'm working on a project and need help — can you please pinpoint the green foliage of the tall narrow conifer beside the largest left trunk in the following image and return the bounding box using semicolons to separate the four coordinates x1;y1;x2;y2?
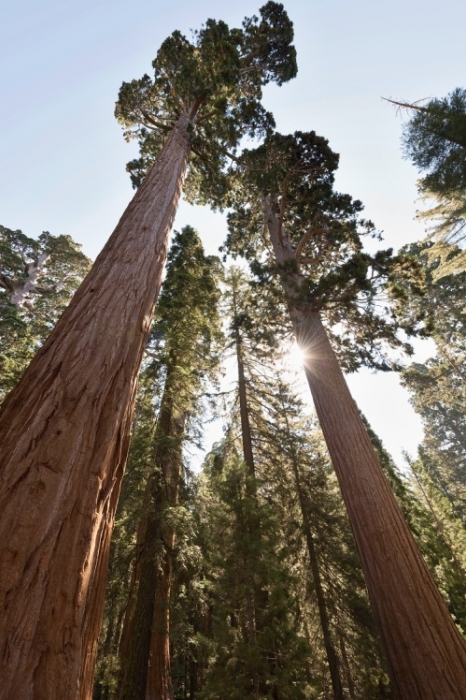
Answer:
94;226;221;699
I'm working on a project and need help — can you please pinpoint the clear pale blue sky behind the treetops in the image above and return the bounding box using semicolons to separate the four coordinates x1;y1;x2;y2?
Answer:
0;0;466;470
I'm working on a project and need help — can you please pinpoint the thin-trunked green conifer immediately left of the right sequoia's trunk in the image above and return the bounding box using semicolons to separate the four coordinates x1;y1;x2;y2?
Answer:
268;388;392;700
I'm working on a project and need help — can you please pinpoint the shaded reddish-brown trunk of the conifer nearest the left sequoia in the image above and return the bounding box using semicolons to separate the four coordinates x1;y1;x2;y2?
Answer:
119;356;187;700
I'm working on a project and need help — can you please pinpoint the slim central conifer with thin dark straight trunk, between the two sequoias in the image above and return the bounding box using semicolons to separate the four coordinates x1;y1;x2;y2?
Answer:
191;268;313;700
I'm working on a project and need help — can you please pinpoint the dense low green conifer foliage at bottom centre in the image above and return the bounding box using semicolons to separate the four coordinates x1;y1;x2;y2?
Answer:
199;445;313;700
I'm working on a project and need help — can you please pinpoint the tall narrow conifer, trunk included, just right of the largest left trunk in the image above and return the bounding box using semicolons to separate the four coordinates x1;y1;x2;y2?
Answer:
94;226;221;700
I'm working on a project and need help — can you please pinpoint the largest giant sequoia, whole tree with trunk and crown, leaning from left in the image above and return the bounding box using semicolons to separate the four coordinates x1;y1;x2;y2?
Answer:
0;2;296;700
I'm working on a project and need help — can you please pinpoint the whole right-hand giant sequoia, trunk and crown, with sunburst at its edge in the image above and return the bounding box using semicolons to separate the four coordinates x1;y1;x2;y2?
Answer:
221;132;466;700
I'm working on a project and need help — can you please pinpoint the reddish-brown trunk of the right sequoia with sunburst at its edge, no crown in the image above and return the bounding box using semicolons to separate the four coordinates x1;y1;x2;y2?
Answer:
264;205;466;700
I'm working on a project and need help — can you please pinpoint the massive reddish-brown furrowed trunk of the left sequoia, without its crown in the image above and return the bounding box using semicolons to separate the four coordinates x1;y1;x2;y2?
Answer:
0;117;190;700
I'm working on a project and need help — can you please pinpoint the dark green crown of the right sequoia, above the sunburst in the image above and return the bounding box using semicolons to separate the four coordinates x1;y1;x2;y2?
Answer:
225;132;421;369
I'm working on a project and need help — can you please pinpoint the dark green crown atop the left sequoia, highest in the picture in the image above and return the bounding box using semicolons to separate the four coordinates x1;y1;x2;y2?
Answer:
115;2;297;199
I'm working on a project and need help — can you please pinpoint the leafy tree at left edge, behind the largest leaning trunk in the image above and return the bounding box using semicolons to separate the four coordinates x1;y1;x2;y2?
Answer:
0;226;91;401
